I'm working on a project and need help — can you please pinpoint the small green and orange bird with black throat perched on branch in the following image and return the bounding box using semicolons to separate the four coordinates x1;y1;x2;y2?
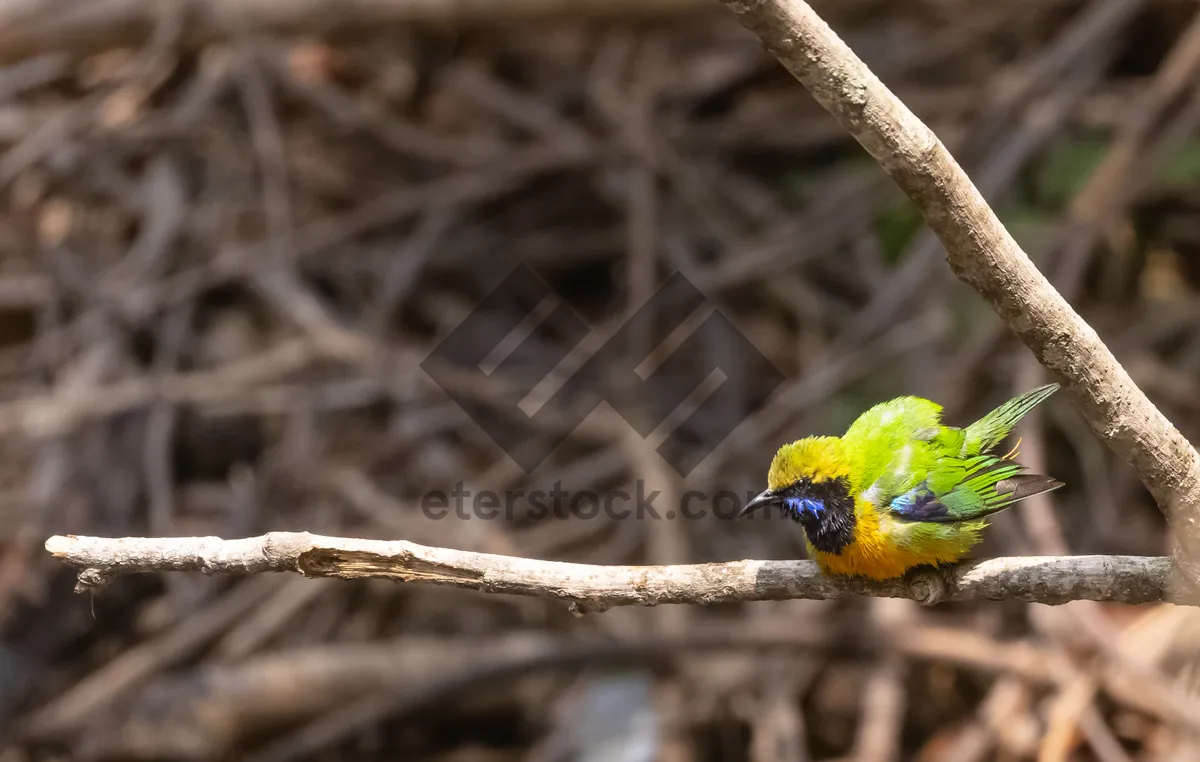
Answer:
738;384;1063;580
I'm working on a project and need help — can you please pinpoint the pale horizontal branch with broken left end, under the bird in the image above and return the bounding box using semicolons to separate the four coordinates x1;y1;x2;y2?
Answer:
46;532;1186;611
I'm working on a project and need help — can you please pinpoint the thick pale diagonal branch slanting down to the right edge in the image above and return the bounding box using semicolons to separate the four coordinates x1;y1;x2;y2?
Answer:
721;0;1200;586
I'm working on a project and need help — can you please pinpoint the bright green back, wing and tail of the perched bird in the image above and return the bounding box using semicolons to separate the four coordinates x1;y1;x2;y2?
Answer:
847;384;1062;522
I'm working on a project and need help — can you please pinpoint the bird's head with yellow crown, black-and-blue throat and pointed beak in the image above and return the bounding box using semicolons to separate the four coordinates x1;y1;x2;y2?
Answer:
739;437;854;553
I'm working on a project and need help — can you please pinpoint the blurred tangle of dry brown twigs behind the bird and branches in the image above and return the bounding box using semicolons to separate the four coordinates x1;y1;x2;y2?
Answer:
0;0;1200;762
